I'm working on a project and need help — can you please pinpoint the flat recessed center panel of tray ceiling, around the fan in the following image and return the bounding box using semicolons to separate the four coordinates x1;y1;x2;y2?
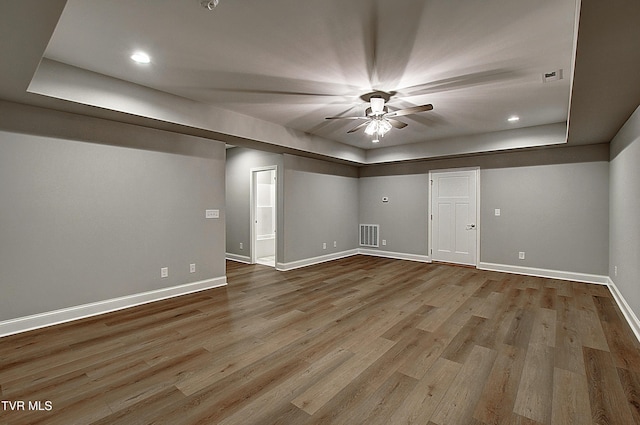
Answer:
45;0;576;149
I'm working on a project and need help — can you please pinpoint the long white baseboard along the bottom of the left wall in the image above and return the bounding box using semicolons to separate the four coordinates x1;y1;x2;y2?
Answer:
0;276;227;337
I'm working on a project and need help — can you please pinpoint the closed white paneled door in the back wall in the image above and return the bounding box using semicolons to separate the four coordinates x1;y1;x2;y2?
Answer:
430;169;478;266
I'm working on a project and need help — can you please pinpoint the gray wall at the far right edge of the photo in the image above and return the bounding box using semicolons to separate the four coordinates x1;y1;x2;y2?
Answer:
609;107;640;316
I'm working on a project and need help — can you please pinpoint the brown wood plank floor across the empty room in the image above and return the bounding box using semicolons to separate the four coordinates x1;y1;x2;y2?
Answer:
0;256;640;425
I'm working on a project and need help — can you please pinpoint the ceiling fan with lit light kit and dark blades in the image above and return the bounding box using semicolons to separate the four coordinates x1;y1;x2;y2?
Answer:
326;91;433;143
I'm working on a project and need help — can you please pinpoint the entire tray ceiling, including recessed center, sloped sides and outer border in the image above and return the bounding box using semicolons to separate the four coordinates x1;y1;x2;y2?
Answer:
0;0;640;164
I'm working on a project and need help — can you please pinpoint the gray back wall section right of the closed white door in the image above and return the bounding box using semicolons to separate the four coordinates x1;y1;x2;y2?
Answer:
480;161;609;275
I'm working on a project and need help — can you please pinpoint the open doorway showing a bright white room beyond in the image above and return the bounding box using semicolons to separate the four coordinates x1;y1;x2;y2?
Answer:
251;165;277;267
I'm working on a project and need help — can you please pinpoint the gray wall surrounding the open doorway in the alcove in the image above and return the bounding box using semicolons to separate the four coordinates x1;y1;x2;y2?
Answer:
226;147;284;261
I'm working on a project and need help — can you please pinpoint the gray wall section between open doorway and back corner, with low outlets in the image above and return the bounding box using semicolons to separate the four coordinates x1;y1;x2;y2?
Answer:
278;154;358;263
